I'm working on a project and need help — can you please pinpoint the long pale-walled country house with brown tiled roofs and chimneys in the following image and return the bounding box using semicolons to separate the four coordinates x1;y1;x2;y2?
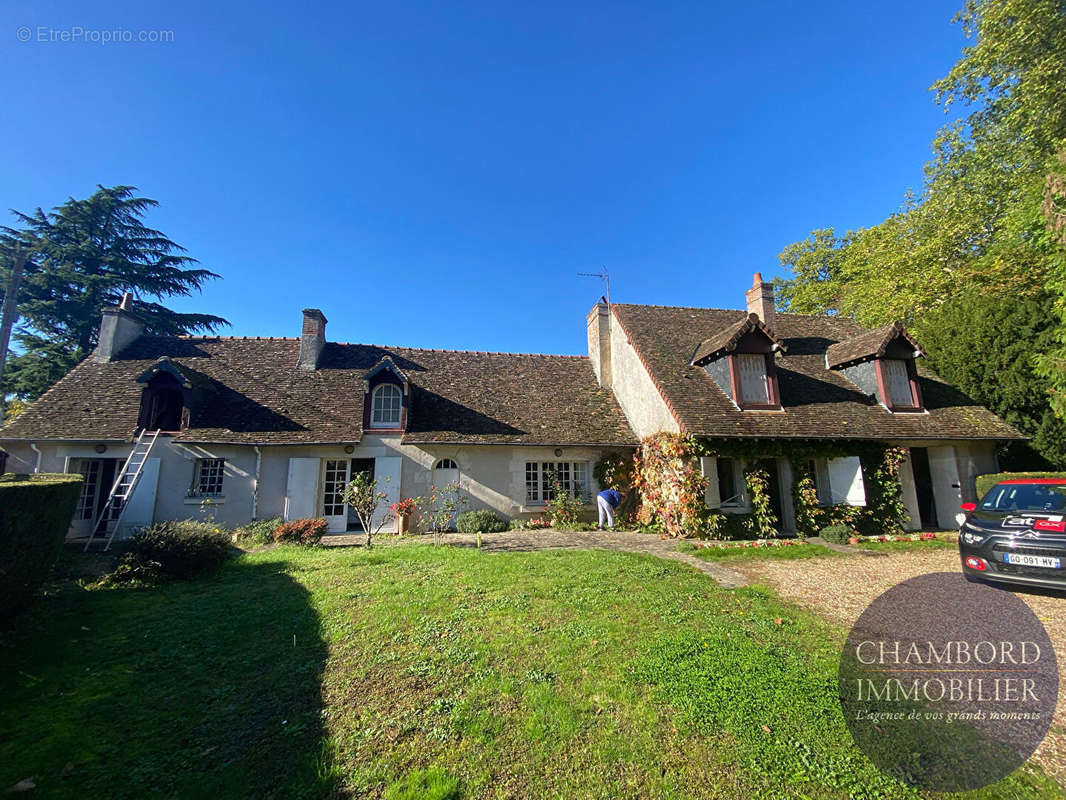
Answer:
0;274;1019;537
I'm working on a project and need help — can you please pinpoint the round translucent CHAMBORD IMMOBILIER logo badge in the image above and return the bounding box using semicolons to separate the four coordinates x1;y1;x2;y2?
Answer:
838;573;1059;791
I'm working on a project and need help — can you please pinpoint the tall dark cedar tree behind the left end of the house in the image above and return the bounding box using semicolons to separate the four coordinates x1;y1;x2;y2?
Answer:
0;186;229;400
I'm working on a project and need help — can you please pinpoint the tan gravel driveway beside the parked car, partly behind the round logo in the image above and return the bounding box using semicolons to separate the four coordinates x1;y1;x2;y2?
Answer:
729;549;1066;783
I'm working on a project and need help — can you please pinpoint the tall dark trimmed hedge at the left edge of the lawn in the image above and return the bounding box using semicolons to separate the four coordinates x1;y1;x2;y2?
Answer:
0;473;82;613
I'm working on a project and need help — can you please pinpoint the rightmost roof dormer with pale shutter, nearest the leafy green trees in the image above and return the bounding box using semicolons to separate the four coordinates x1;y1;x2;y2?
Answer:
825;322;924;412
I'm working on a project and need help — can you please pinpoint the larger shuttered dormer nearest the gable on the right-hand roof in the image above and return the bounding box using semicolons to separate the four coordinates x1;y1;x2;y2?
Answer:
692;314;784;411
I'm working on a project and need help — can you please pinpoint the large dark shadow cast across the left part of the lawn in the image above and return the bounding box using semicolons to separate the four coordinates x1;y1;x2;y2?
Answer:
0;560;333;798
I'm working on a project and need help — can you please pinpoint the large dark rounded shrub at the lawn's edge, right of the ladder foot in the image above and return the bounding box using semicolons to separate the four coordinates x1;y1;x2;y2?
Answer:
123;519;233;580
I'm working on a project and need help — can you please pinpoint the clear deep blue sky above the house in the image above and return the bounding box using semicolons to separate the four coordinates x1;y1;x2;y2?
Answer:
0;0;965;353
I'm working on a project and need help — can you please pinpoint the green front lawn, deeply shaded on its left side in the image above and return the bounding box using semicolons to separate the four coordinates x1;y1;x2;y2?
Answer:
0;545;1060;800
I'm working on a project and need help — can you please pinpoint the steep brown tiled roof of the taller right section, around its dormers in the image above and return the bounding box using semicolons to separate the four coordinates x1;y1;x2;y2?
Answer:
612;304;1020;441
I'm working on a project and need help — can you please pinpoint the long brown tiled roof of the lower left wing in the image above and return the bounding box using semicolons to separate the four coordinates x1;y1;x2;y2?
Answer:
0;336;635;445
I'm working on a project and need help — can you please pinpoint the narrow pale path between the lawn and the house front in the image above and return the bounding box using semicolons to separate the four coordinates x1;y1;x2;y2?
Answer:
322;530;747;589
